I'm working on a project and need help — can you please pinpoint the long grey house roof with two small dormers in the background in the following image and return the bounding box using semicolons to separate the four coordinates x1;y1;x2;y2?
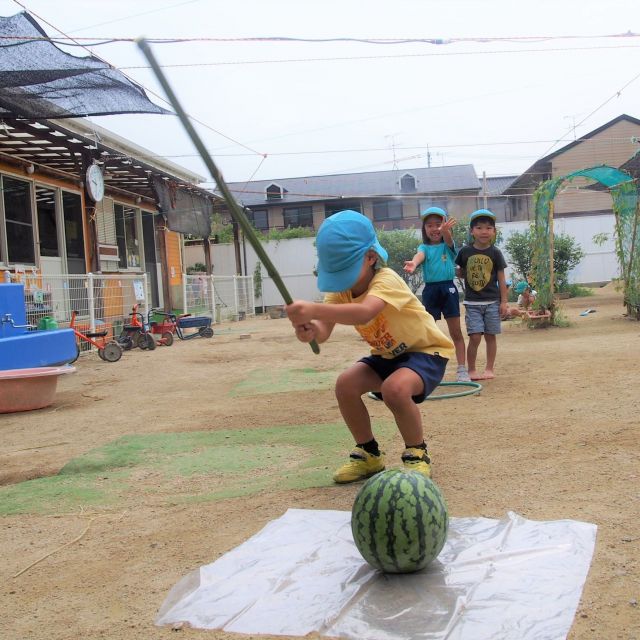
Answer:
222;164;480;206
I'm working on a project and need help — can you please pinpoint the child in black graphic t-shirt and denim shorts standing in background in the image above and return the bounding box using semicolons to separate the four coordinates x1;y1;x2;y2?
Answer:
456;209;509;380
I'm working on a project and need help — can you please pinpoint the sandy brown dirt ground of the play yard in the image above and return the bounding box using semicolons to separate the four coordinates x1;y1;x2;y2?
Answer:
0;285;640;640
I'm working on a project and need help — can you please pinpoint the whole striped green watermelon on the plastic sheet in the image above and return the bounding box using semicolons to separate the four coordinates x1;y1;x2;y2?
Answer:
351;469;449;573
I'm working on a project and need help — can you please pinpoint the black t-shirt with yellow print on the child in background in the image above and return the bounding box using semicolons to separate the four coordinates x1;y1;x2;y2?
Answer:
456;245;507;303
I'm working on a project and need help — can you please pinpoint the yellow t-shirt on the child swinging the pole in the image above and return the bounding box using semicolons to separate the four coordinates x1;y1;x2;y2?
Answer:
324;267;455;360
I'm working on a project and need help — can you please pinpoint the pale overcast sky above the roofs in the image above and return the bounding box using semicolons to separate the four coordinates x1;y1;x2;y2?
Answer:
5;0;640;186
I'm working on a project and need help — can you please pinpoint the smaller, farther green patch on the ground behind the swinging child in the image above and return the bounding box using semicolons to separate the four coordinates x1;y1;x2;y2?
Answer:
230;368;338;397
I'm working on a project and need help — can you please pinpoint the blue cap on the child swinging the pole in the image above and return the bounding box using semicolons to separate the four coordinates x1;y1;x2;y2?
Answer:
316;209;389;293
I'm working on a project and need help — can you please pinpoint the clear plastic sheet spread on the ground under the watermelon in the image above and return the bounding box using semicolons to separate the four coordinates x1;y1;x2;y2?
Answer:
156;509;596;640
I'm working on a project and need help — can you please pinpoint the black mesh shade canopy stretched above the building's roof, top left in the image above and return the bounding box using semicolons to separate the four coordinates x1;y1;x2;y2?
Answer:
0;13;170;118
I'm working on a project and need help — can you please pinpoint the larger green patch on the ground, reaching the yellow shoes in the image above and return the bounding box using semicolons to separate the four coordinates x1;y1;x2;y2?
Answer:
0;422;398;515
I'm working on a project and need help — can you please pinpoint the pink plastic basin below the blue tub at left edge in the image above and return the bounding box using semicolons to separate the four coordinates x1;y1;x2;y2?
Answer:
0;366;76;413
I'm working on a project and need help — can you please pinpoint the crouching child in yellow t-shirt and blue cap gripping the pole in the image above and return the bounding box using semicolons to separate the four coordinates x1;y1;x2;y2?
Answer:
286;210;454;483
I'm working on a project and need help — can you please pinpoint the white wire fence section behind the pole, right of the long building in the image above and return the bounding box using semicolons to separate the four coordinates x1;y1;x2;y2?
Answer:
182;273;255;322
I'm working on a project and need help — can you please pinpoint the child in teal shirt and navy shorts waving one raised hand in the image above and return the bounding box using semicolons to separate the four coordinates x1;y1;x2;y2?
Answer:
404;207;470;382
